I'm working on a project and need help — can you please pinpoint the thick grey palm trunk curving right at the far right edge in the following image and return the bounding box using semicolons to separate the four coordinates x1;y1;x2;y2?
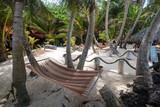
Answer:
136;11;160;88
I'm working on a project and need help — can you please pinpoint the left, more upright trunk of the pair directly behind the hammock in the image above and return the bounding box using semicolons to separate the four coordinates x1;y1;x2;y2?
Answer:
66;12;75;68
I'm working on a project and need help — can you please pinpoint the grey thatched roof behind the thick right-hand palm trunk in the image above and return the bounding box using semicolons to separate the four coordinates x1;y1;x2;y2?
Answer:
128;28;160;43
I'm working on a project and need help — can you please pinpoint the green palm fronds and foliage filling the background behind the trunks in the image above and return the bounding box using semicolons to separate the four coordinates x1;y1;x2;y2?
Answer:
1;0;159;50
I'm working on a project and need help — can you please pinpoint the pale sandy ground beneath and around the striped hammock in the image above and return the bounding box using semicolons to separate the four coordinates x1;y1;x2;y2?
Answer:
0;47;136;107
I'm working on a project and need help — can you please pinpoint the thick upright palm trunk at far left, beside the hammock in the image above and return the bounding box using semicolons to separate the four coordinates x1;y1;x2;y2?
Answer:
12;0;29;107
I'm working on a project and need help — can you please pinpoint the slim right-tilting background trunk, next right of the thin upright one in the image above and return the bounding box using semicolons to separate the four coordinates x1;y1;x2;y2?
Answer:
117;0;130;45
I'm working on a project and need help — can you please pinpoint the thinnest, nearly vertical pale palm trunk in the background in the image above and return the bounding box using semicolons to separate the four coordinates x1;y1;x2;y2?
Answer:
105;0;110;42
